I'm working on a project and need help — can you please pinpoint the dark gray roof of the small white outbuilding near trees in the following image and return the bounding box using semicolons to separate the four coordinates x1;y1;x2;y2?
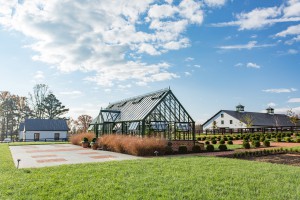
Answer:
20;119;69;131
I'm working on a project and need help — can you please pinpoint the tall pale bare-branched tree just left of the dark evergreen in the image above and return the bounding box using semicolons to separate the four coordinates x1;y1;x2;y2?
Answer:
29;84;49;119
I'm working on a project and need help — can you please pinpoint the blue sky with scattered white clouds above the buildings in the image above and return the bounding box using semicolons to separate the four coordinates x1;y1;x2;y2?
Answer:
0;0;300;122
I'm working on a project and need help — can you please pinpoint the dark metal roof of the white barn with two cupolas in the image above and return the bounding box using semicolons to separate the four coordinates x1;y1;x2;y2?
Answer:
203;110;294;127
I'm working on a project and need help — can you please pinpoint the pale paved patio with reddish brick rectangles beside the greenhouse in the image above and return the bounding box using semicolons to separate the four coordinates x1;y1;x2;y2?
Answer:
9;144;141;168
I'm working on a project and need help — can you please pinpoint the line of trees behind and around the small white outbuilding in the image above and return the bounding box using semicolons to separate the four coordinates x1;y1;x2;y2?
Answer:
0;84;92;140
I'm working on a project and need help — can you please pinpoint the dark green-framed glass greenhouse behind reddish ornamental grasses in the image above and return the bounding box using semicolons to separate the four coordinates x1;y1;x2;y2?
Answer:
89;88;195;141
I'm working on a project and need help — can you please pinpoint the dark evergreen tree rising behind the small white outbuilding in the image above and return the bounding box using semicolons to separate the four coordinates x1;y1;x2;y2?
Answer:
39;93;69;119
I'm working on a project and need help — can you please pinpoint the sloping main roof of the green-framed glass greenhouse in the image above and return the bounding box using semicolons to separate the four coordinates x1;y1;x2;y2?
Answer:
105;89;170;121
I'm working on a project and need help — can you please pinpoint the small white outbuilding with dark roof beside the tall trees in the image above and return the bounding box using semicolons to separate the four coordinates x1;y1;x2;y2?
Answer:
19;119;69;141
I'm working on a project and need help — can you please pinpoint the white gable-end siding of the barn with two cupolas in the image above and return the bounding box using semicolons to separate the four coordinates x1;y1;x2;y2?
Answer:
203;111;246;130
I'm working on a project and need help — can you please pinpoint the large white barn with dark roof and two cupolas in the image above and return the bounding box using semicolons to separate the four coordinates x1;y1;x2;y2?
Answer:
203;105;294;132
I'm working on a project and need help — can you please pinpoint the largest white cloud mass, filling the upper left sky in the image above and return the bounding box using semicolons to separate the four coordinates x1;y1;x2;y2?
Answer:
0;0;203;87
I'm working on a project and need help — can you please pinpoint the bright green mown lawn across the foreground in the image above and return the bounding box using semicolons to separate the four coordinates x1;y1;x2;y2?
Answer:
0;144;300;200
